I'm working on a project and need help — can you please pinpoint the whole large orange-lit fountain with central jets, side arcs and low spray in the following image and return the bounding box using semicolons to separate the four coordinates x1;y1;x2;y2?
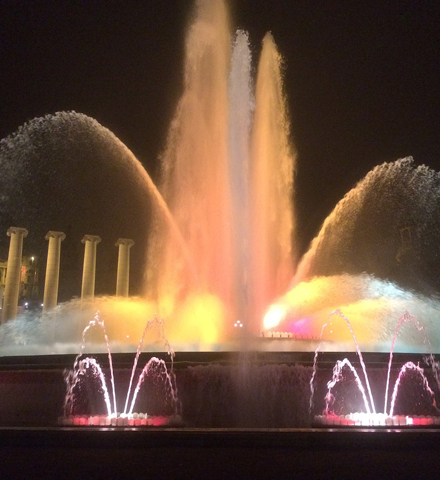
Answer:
0;1;440;432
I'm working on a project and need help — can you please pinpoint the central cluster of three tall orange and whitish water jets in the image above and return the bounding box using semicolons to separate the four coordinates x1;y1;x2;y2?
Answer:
149;1;294;333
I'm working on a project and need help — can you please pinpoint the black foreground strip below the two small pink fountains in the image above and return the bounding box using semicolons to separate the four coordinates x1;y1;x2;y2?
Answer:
0;429;440;479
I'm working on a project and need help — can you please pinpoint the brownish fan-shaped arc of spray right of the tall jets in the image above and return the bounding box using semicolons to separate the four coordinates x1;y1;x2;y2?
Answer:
294;157;440;294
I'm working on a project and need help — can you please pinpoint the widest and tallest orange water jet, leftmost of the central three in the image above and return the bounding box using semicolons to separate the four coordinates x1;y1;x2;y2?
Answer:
148;1;233;317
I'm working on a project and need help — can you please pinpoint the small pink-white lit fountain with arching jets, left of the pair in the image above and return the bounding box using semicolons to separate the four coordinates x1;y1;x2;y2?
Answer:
59;313;180;426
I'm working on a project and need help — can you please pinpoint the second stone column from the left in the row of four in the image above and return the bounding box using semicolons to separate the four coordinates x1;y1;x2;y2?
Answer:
43;230;66;312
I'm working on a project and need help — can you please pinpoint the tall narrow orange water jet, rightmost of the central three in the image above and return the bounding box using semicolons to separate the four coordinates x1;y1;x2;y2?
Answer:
251;33;295;328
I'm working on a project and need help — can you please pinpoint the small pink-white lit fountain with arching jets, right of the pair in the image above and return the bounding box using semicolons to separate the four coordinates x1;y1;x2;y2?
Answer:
310;310;440;426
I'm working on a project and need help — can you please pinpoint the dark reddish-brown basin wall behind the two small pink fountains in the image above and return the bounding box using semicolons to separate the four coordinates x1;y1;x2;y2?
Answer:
0;352;436;429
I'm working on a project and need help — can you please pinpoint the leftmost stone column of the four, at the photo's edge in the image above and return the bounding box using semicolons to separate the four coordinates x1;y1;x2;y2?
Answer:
2;227;28;323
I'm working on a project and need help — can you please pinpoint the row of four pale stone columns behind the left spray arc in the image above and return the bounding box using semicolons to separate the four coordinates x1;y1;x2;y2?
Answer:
2;227;134;323
